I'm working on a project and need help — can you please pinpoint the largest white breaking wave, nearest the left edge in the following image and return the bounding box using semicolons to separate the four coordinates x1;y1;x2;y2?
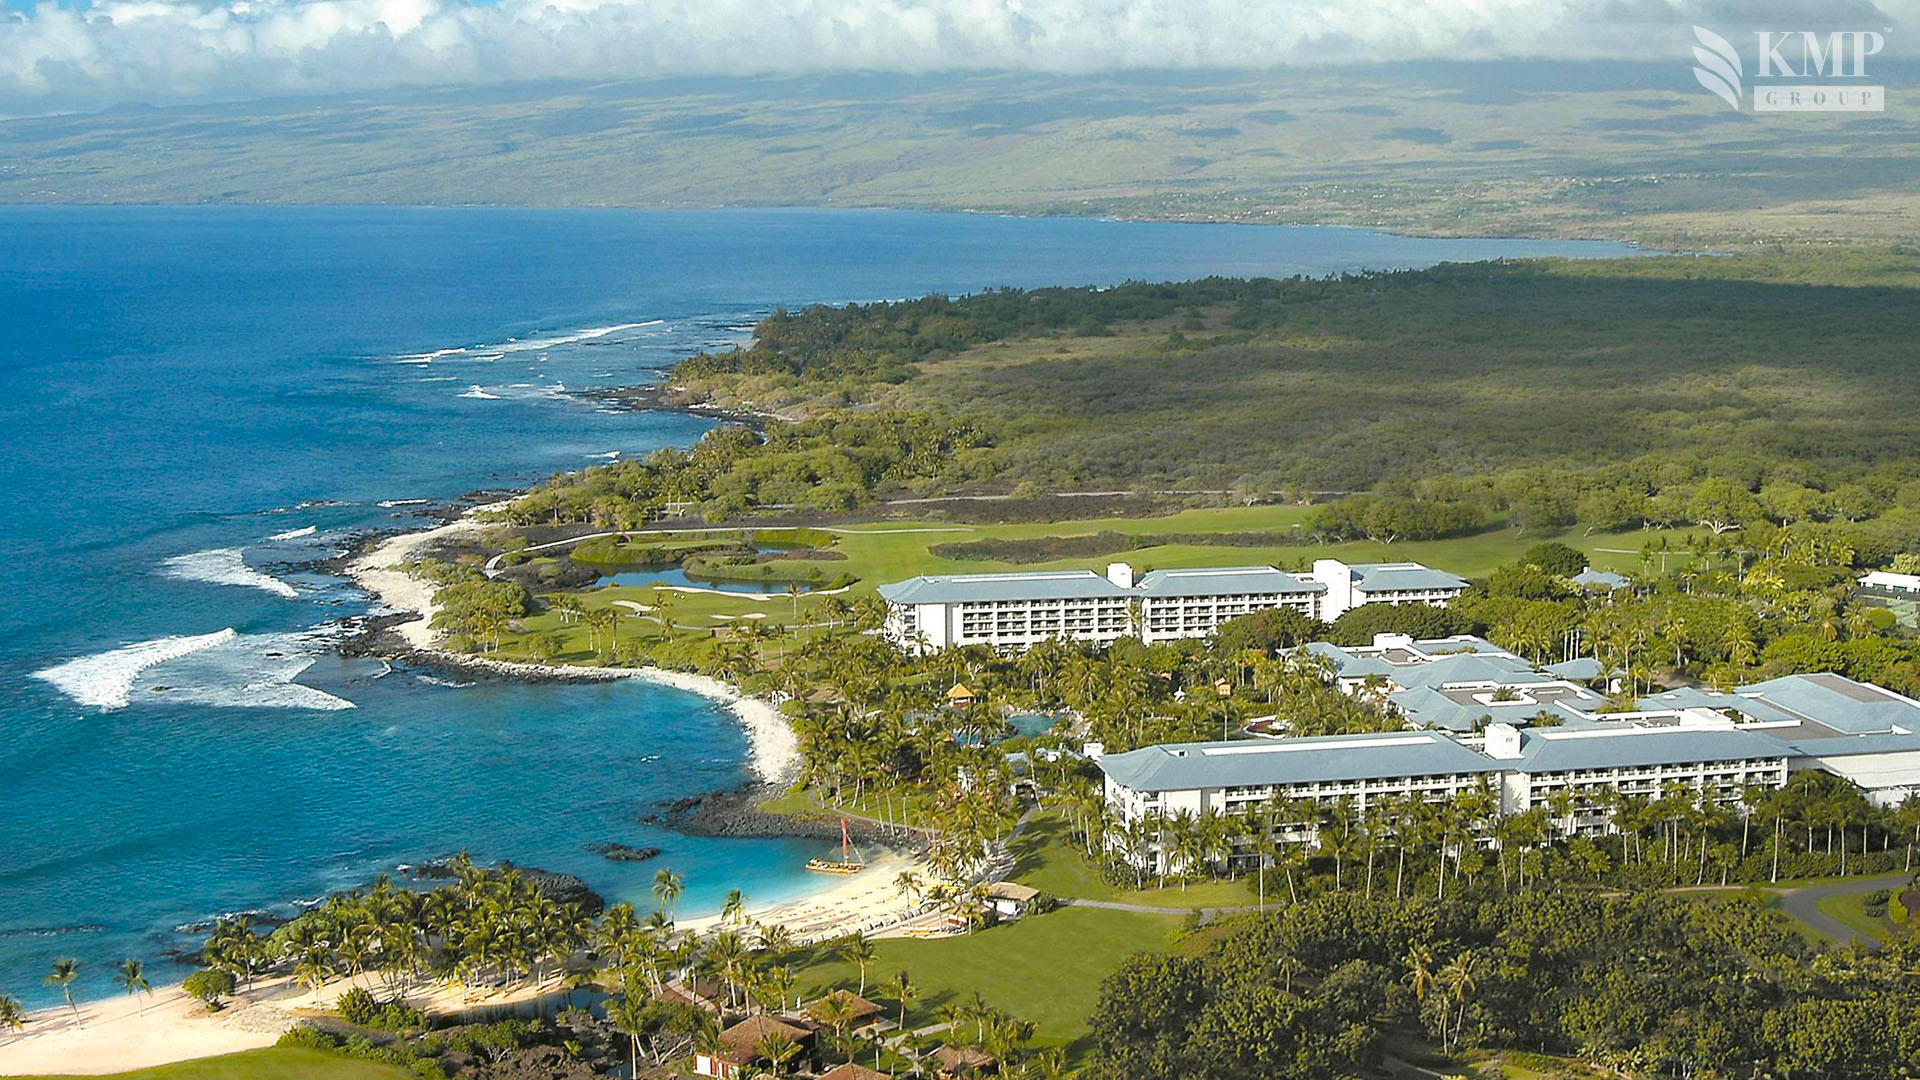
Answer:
33;626;353;711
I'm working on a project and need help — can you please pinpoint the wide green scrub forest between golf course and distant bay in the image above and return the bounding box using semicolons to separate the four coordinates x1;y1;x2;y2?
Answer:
511;252;1920;561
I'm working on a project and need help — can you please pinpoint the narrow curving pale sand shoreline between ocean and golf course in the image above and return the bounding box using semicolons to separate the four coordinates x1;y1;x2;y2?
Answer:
344;503;801;786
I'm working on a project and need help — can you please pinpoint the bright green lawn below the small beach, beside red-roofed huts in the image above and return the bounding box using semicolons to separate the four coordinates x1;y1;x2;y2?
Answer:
779;907;1179;1045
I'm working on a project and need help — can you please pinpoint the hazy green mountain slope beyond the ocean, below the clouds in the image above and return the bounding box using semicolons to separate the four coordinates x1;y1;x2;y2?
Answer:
0;63;1920;246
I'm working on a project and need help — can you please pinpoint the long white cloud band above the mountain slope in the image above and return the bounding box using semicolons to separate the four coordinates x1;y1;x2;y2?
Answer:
0;0;1920;108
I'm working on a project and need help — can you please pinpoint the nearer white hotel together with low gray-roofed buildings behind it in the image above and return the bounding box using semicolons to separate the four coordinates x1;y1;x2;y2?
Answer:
1089;634;1920;872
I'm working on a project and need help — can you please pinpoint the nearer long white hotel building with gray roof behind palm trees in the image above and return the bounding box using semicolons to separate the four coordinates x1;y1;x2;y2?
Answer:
1089;673;1920;872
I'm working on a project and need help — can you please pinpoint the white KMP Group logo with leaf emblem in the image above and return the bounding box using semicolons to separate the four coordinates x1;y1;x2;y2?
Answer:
1693;27;1887;113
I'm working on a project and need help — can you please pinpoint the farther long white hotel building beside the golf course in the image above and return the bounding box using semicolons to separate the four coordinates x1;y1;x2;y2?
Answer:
879;559;1467;651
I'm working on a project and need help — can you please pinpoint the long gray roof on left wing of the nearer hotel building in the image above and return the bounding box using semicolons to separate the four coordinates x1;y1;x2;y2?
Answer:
1100;732;1500;792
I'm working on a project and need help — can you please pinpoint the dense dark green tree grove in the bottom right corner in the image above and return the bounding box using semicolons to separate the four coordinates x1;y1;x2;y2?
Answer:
1087;890;1920;1080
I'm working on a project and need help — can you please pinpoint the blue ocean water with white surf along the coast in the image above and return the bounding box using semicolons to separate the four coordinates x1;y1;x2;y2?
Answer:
0;208;1624;1003
